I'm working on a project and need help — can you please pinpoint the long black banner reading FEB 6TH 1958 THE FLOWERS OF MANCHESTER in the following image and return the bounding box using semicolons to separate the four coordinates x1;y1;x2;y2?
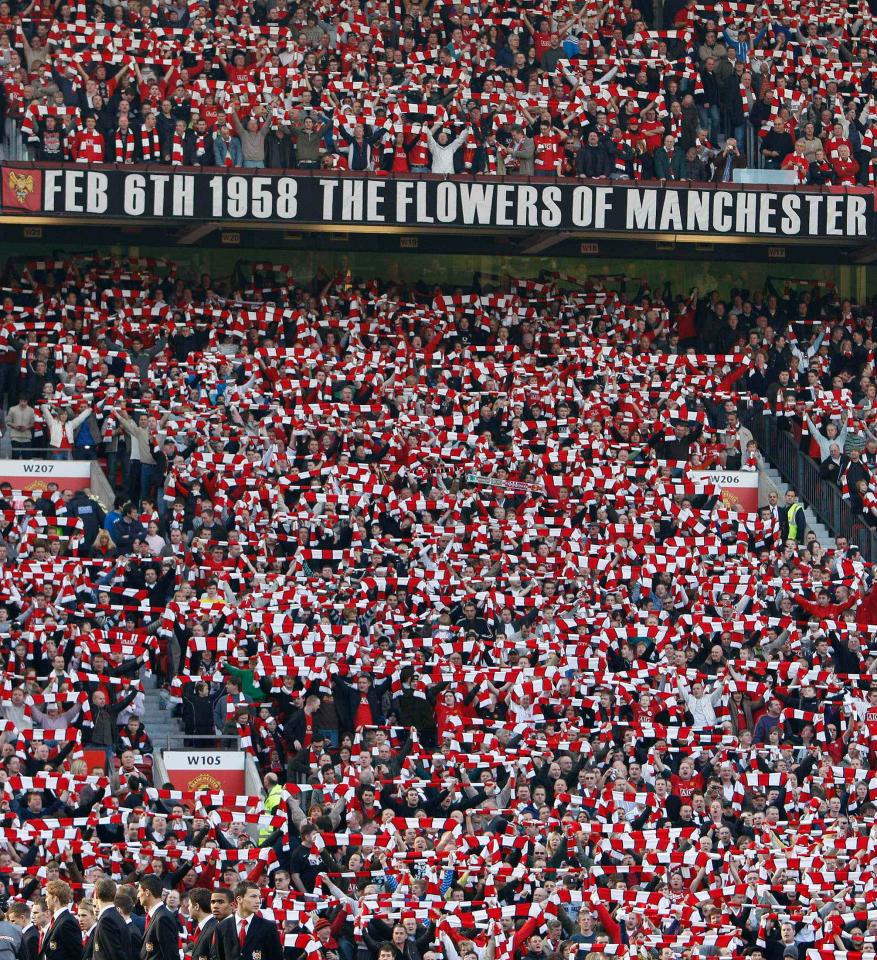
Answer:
2;165;875;241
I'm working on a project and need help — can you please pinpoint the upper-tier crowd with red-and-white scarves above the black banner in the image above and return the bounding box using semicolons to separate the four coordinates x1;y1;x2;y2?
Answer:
0;0;877;185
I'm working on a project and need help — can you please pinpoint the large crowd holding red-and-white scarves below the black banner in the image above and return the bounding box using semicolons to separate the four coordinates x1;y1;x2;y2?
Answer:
0;255;877;960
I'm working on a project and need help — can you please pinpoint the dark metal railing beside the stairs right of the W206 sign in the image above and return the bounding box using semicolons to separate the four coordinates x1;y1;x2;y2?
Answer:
745;410;877;563
